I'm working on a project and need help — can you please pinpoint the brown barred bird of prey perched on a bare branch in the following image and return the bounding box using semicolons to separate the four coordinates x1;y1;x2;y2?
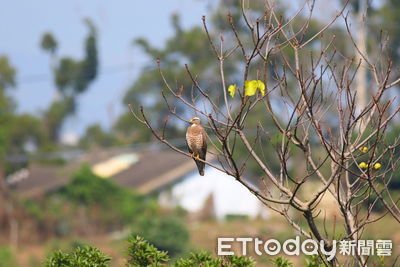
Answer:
186;117;207;176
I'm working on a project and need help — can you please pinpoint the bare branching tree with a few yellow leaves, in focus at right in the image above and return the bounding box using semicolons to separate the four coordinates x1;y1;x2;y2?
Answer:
130;1;400;266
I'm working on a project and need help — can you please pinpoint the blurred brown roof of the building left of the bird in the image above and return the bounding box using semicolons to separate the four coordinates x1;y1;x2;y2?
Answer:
12;149;196;197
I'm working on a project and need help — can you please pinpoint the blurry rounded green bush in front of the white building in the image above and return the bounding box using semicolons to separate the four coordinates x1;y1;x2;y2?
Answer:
133;214;189;256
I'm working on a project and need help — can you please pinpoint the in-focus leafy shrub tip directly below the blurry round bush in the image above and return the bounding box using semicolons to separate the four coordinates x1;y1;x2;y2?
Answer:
127;236;169;266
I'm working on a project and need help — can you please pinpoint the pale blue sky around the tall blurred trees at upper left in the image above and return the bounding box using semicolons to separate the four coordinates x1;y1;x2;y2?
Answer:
0;0;212;141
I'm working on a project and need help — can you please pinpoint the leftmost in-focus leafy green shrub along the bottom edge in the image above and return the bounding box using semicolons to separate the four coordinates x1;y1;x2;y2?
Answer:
45;246;111;267
